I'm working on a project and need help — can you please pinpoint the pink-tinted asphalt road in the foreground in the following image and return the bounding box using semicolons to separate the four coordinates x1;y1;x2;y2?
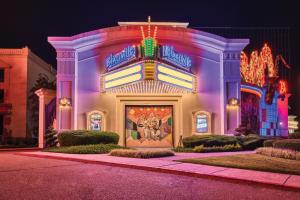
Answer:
0;152;300;200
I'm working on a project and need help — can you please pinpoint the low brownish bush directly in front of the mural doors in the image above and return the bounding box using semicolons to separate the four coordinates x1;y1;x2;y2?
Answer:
109;149;174;158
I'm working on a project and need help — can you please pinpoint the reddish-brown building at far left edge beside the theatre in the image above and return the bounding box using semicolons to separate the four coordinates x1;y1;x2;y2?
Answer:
0;47;56;142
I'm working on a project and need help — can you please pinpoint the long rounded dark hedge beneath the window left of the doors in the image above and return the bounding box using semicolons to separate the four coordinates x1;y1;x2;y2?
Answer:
58;130;119;146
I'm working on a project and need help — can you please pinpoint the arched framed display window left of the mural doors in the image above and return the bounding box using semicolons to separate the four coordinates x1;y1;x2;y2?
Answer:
87;110;105;131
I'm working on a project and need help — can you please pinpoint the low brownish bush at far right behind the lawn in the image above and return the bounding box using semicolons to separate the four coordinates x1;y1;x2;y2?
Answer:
256;147;299;160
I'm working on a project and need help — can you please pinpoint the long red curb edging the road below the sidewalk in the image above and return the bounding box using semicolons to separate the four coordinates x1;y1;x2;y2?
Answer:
15;152;300;191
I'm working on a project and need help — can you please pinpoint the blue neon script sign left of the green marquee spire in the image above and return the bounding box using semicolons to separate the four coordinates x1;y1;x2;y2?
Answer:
105;45;136;69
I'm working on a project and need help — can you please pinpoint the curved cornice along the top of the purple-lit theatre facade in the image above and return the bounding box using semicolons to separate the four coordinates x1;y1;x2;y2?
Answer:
48;25;249;51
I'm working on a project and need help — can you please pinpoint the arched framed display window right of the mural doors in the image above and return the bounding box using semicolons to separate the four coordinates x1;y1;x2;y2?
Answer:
192;111;211;134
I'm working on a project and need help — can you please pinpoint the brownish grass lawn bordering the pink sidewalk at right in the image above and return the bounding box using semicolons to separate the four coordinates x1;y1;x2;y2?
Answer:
179;154;300;175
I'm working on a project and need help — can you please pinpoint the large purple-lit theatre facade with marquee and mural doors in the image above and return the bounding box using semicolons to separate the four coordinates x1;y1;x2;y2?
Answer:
48;20;249;147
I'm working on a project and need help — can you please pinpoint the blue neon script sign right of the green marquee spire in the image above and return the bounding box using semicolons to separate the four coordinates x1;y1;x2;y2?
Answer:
161;45;192;69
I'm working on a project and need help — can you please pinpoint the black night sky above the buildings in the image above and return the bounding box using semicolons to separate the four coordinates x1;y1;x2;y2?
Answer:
0;0;300;115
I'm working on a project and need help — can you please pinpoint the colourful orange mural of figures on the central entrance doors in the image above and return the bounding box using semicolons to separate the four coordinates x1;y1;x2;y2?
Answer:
125;105;173;147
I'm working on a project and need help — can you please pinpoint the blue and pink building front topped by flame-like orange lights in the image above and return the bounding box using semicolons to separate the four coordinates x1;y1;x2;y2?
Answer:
241;44;290;136
